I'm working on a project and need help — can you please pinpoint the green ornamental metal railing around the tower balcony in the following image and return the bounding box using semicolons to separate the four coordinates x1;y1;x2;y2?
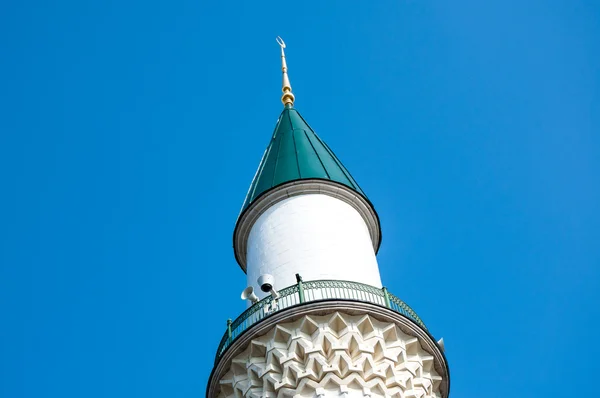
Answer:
215;277;427;362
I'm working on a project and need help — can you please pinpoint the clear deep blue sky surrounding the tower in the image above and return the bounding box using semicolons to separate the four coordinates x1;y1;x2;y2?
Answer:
0;0;600;398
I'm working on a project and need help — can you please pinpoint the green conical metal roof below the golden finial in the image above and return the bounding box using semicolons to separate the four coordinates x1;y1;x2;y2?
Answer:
242;105;366;212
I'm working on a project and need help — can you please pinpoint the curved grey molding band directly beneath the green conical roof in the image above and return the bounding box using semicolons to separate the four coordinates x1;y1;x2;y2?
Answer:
233;179;381;272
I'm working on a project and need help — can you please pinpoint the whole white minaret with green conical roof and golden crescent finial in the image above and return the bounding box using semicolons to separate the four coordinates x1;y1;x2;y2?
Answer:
207;38;450;398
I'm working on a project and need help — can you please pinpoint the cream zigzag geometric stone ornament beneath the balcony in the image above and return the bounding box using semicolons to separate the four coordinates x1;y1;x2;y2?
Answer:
215;311;442;398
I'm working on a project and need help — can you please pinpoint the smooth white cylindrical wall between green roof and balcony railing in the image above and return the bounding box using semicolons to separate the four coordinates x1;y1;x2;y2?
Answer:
247;194;381;297
